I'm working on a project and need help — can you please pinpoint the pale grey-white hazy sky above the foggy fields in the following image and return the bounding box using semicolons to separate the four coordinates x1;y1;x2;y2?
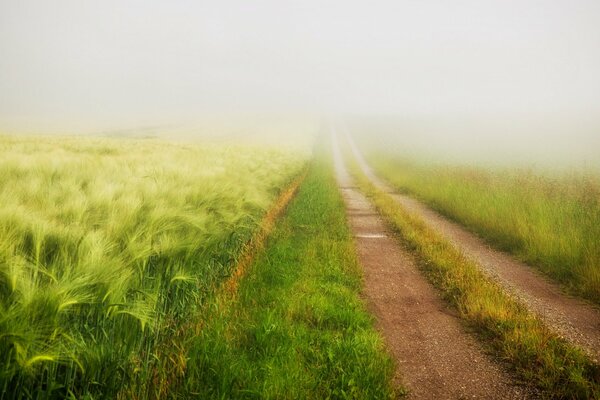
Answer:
0;0;600;130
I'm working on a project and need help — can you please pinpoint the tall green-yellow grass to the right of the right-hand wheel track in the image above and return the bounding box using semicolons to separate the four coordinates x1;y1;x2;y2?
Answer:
356;141;600;304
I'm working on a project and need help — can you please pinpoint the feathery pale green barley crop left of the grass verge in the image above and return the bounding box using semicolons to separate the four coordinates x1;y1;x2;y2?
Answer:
0;137;306;399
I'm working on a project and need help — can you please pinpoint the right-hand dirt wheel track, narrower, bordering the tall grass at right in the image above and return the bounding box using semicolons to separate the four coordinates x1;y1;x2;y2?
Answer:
348;131;600;362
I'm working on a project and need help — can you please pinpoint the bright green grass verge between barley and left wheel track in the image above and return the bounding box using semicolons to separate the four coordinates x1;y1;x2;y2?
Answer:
183;145;394;398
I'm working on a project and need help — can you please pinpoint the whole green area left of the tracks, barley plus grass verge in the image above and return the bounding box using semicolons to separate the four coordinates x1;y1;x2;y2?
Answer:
0;129;398;399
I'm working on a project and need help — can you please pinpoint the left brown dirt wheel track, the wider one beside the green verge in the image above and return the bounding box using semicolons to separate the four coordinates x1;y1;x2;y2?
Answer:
332;130;527;399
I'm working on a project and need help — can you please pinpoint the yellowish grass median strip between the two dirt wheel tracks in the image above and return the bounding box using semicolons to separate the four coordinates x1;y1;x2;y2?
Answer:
346;141;600;399
